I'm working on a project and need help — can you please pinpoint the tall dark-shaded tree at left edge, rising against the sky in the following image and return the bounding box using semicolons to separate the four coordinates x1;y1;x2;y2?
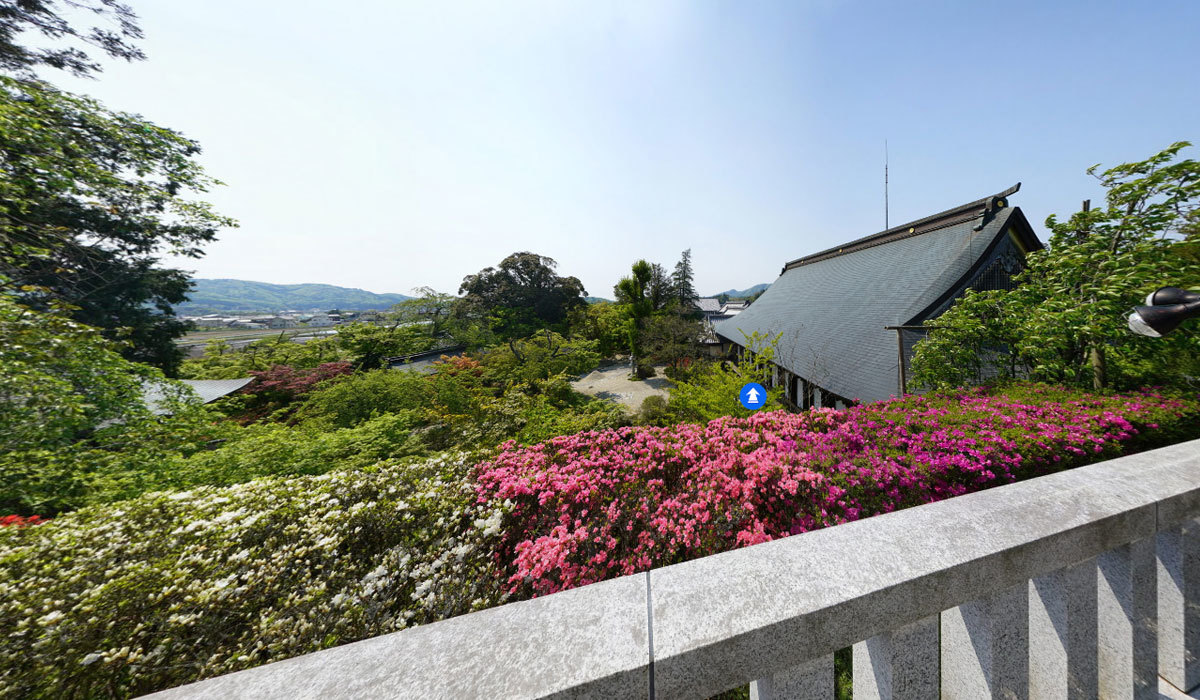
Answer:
0;77;234;372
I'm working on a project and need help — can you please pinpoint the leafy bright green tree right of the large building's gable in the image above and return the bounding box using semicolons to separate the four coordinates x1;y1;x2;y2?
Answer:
912;142;1200;389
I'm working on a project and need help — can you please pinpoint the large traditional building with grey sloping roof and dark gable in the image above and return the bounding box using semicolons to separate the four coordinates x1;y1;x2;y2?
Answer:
714;184;1043;408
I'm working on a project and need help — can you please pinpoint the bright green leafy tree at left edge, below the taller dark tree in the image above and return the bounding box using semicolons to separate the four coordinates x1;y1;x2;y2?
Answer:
0;294;243;515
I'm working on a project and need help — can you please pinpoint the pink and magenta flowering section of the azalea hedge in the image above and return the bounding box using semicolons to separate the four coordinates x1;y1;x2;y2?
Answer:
476;387;1198;596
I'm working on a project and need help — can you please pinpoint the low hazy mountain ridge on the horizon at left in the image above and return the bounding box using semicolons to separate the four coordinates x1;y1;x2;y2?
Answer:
175;280;412;316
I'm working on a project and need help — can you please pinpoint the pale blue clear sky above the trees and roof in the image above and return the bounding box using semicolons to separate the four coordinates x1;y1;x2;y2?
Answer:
52;0;1200;298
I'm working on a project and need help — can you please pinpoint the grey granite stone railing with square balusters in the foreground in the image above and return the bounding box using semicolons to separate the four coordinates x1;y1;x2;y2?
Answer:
147;441;1200;700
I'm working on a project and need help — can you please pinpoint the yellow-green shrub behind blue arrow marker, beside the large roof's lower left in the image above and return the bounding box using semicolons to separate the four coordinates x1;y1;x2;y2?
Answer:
670;331;784;423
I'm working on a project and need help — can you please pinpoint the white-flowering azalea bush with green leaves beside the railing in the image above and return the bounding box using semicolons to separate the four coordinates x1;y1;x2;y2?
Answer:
0;454;506;698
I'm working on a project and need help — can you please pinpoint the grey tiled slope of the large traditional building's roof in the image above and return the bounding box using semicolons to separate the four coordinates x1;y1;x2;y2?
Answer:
714;200;1019;401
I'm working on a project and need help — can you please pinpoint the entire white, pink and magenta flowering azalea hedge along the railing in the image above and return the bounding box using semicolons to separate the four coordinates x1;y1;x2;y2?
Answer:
0;387;1200;698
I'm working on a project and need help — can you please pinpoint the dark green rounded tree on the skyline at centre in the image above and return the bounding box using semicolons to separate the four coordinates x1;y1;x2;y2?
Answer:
458;252;587;340
